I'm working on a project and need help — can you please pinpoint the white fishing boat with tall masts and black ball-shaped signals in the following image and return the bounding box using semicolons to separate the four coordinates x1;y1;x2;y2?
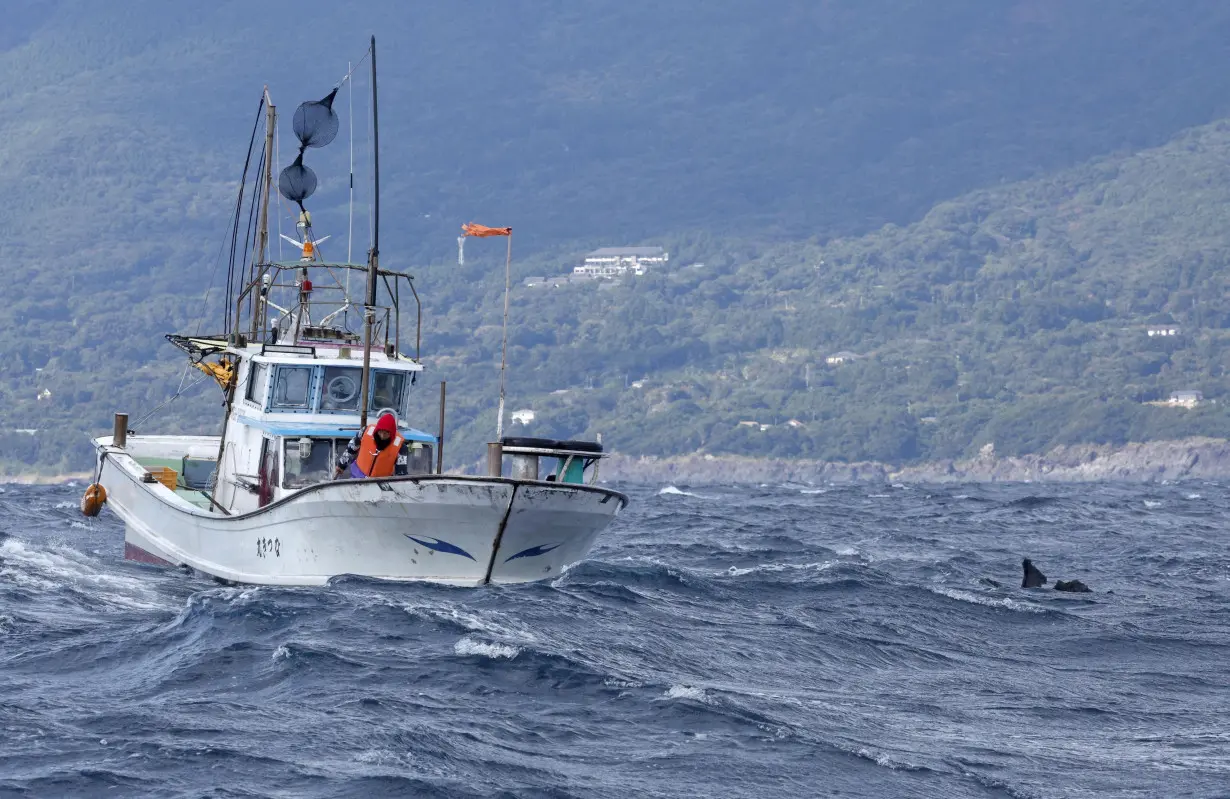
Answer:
82;37;627;586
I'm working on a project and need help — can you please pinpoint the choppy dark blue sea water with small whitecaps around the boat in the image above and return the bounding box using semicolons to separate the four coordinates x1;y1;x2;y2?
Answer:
0;483;1230;799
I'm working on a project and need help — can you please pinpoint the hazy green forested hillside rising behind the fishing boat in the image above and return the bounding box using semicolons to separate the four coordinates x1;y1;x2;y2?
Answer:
0;0;1230;471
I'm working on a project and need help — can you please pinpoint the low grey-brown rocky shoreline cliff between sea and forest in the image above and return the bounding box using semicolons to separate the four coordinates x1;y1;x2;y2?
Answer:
601;439;1230;484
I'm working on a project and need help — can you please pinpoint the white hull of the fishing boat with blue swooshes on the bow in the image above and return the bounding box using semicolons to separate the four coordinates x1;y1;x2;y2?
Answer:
98;441;627;585
